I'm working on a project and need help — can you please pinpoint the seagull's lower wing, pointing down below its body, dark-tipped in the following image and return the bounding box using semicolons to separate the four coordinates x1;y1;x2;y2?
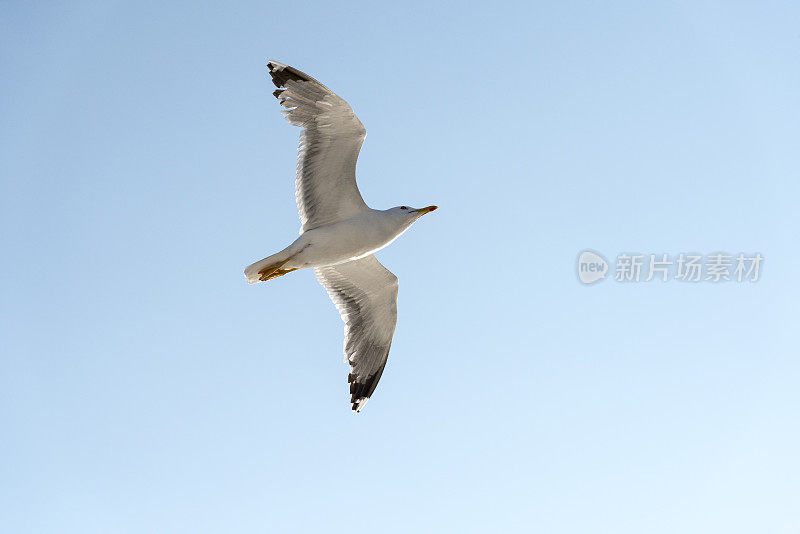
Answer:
314;255;397;412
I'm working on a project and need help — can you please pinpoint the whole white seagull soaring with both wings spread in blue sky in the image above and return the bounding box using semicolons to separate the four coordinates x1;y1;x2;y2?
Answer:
244;61;437;412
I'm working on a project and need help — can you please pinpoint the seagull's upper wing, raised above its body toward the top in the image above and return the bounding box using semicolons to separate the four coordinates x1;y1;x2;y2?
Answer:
267;61;368;232
